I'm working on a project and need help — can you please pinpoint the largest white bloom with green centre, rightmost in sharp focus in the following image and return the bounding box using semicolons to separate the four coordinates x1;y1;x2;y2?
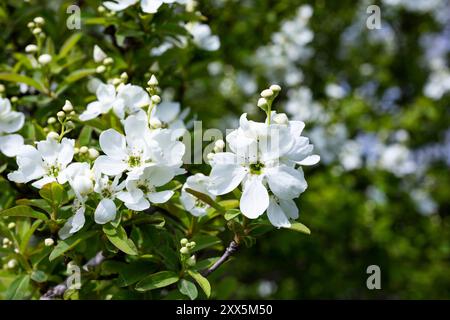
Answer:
209;113;320;227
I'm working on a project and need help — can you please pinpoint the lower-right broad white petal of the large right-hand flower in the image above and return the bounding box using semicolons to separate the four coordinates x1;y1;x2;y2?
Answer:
266;165;308;199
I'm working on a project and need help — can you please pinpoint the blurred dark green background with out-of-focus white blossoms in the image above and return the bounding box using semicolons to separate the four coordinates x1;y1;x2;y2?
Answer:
0;0;450;299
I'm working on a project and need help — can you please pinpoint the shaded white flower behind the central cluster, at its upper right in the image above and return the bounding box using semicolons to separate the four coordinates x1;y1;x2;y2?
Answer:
151;102;189;138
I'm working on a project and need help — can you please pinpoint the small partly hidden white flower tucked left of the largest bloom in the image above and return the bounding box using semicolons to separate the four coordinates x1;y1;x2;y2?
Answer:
180;173;216;217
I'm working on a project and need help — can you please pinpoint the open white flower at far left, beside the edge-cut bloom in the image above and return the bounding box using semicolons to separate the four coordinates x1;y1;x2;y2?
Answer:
8;138;74;189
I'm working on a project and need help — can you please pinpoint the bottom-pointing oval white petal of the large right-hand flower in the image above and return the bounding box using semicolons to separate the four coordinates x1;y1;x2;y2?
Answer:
240;176;269;219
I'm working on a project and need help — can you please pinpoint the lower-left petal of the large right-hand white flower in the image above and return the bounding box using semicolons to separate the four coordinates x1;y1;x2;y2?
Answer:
209;164;247;195
